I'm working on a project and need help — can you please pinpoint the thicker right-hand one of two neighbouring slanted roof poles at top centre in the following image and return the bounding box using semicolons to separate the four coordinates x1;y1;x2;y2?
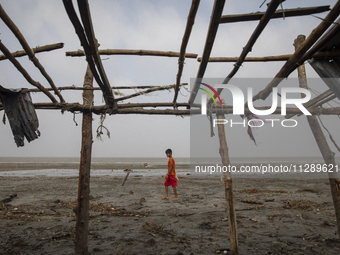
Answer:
189;0;225;105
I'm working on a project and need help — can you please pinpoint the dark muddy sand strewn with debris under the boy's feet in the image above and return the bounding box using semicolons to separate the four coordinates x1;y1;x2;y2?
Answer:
0;171;340;255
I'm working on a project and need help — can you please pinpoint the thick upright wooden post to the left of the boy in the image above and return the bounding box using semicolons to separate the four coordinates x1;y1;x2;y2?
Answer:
75;66;93;255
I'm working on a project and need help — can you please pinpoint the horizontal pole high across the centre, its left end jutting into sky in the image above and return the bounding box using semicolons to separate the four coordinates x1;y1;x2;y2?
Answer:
66;49;198;58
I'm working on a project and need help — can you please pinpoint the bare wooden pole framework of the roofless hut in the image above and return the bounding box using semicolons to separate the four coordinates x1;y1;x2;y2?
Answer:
0;0;340;254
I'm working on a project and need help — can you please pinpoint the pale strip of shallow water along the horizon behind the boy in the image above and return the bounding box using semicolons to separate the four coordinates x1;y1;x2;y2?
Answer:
0;157;340;178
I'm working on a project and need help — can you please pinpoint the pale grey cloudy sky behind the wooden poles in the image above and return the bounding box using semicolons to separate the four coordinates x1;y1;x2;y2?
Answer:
0;0;340;157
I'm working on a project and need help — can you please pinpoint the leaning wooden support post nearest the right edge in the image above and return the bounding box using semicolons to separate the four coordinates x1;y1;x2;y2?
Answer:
294;35;340;238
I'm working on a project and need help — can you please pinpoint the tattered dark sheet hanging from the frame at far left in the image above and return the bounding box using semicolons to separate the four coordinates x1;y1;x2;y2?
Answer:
0;86;40;147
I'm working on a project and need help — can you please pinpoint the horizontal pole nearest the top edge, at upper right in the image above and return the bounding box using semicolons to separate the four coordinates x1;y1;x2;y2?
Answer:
220;5;330;23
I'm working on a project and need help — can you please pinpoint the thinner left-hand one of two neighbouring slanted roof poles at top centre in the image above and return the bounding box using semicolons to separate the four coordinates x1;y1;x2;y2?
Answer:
173;0;200;103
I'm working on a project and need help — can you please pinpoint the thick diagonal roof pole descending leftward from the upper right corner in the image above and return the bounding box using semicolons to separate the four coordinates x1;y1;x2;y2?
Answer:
253;0;340;101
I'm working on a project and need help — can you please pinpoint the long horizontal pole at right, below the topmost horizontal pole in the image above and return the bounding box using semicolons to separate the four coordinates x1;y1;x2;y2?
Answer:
197;50;340;62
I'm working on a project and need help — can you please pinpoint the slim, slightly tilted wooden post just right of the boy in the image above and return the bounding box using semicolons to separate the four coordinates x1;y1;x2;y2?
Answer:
217;112;239;255
